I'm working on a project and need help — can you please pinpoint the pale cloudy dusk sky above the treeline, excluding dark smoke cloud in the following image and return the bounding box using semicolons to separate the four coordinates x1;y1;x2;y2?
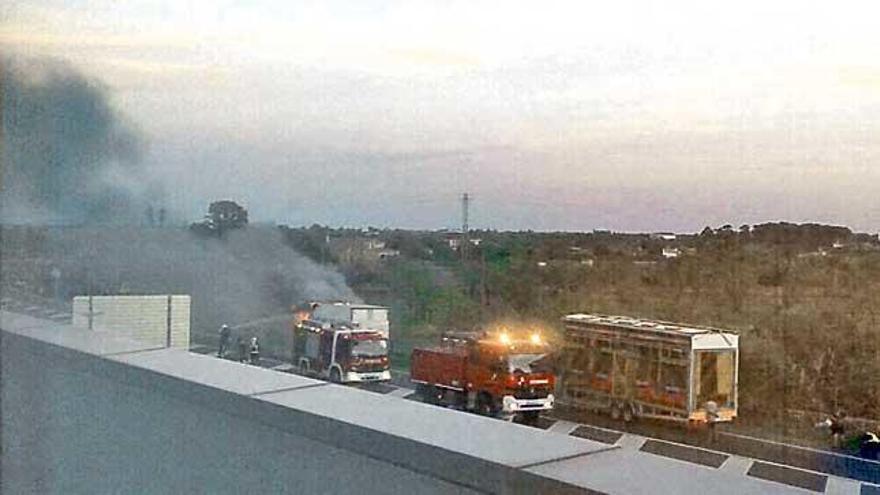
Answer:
0;0;880;232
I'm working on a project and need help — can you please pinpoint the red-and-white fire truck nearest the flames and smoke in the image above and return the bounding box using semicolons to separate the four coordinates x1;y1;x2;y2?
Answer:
292;303;391;383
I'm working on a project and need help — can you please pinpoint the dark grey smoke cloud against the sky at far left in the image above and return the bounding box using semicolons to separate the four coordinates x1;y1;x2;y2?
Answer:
0;58;143;224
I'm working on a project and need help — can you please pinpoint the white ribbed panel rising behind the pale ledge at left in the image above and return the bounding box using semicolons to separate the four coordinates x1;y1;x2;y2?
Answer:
73;295;190;349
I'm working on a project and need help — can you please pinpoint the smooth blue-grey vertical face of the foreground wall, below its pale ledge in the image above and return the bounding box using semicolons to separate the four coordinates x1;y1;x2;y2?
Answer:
0;335;475;494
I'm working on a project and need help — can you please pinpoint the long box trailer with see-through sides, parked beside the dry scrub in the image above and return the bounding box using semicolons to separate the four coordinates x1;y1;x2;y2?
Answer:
559;314;739;423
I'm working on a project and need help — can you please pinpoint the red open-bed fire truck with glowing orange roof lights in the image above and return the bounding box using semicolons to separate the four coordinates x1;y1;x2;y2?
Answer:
410;332;556;422
